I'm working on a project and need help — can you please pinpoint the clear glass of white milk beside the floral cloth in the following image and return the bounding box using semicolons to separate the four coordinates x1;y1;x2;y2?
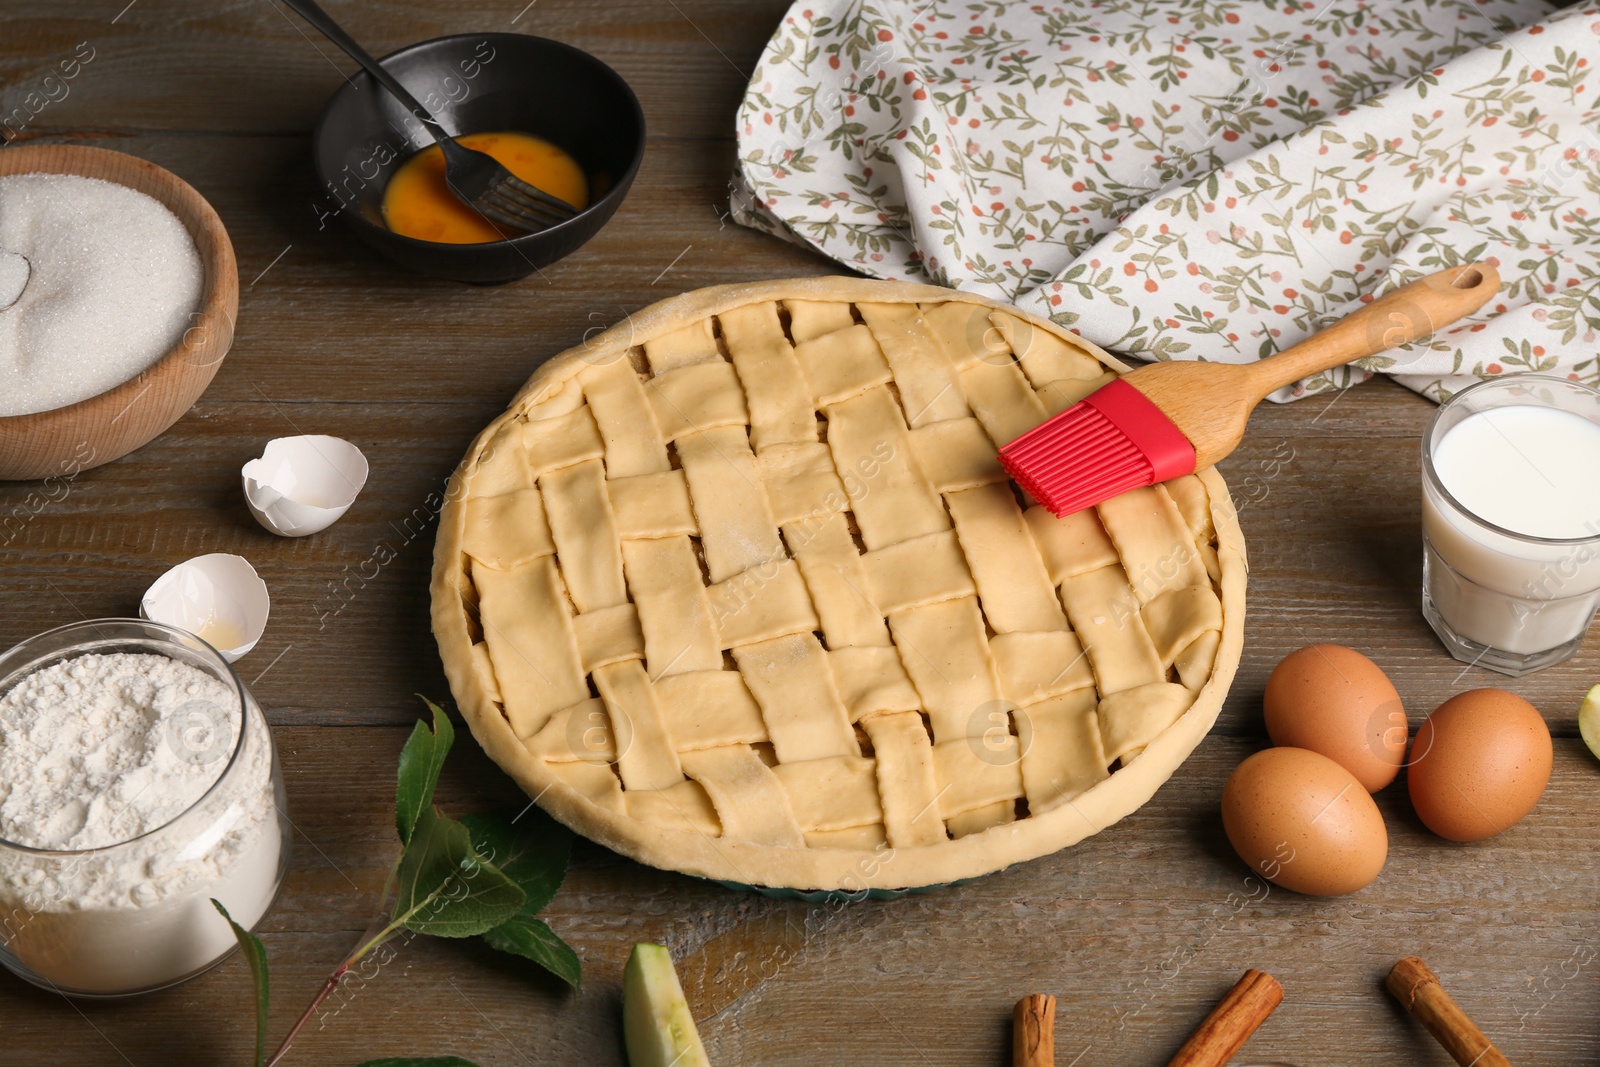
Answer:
1422;374;1600;675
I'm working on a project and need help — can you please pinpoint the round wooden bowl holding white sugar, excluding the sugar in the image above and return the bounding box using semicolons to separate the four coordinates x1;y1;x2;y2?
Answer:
0;144;238;480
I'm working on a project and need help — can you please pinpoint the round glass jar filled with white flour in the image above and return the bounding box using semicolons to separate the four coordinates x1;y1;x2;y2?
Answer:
0;619;290;997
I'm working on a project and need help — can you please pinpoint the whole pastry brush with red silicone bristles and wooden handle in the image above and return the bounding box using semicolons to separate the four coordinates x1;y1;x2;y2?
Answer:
1000;262;1499;515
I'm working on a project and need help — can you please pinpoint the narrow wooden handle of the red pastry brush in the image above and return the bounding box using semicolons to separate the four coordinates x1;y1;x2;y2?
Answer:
1248;262;1499;400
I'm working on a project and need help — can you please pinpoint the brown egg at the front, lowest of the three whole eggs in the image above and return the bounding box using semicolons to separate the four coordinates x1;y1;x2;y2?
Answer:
1222;749;1389;896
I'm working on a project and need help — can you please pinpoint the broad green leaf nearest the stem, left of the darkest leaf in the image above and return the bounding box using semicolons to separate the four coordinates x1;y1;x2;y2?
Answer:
394;805;528;937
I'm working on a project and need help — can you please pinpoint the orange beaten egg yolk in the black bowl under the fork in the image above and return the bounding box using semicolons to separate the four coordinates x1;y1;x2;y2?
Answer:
384;131;589;245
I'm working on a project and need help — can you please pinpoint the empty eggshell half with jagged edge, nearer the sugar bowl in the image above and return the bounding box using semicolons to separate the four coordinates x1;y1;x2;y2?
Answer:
240;434;368;537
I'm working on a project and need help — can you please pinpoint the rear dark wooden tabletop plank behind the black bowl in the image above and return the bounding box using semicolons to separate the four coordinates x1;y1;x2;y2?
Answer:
0;0;789;138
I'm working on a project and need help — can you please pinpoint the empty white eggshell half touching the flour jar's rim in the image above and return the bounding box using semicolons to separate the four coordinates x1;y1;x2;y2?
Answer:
139;552;270;662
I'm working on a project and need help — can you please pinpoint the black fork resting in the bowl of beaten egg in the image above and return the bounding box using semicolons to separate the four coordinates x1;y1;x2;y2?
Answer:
283;0;578;234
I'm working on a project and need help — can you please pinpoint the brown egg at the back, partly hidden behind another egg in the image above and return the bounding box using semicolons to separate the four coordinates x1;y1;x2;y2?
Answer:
1262;645;1411;793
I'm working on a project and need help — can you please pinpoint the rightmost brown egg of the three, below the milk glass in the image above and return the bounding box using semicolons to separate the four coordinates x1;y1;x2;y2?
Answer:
1406;689;1554;841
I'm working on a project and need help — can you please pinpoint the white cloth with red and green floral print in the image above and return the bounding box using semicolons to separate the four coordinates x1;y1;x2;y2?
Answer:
734;0;1600;400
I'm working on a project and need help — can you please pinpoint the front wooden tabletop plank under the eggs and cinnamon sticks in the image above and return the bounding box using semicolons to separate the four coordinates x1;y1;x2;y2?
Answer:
0;725;1600;1067
